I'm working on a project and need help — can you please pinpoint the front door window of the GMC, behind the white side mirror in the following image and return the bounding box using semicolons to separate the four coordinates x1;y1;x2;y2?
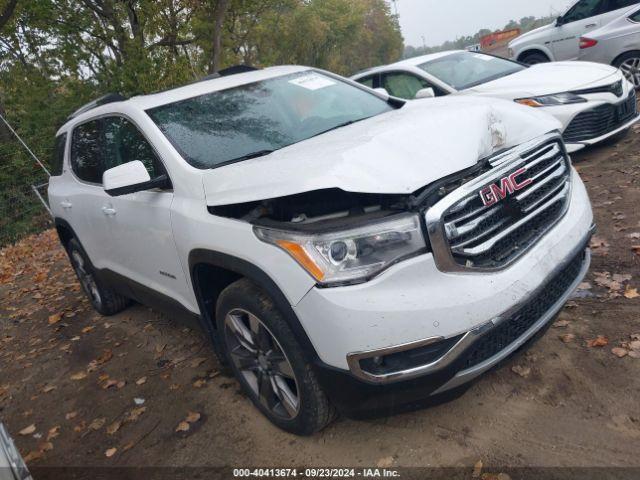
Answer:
104;117;165;179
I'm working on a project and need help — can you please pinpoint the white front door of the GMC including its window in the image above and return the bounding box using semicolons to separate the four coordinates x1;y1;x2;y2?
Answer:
102;116;193;312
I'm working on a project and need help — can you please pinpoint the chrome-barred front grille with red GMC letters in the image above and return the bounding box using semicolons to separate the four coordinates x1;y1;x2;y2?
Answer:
426;135;571;271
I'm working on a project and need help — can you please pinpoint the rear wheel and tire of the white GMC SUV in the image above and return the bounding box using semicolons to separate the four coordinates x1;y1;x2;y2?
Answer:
67;238;131;316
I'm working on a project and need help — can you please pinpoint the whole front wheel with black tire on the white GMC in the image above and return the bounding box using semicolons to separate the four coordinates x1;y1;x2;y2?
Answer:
216;279;334;435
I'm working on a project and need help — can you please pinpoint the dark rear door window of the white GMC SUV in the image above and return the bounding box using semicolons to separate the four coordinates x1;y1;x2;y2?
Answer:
71;120;104;183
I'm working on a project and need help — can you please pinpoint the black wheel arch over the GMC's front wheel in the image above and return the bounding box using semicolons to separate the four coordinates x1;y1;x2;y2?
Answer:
189;253;319;363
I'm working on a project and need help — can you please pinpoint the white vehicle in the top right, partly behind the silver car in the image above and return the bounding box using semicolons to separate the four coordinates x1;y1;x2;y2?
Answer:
509;0;640;65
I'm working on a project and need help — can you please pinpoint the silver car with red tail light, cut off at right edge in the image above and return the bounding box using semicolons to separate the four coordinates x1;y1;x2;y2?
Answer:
579;7;640;90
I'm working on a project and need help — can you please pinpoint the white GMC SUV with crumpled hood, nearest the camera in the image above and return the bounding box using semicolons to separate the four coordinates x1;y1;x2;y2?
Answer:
49;67;593;434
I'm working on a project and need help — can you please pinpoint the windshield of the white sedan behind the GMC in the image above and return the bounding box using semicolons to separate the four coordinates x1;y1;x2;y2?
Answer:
418;52;527;90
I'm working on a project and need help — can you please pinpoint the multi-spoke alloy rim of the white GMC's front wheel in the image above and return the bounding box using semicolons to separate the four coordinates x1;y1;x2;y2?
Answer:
224;309;300;420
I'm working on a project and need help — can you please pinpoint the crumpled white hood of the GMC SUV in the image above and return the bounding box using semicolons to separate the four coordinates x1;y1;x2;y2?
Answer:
203;97;560;206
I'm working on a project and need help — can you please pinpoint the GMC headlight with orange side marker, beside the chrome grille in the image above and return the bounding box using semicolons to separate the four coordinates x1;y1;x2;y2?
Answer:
254;215;426;286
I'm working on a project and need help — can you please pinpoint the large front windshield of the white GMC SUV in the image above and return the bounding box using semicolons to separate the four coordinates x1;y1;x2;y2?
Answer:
147;71;393;168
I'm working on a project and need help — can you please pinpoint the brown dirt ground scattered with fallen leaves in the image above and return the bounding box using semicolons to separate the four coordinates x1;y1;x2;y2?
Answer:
0;123;640;480
